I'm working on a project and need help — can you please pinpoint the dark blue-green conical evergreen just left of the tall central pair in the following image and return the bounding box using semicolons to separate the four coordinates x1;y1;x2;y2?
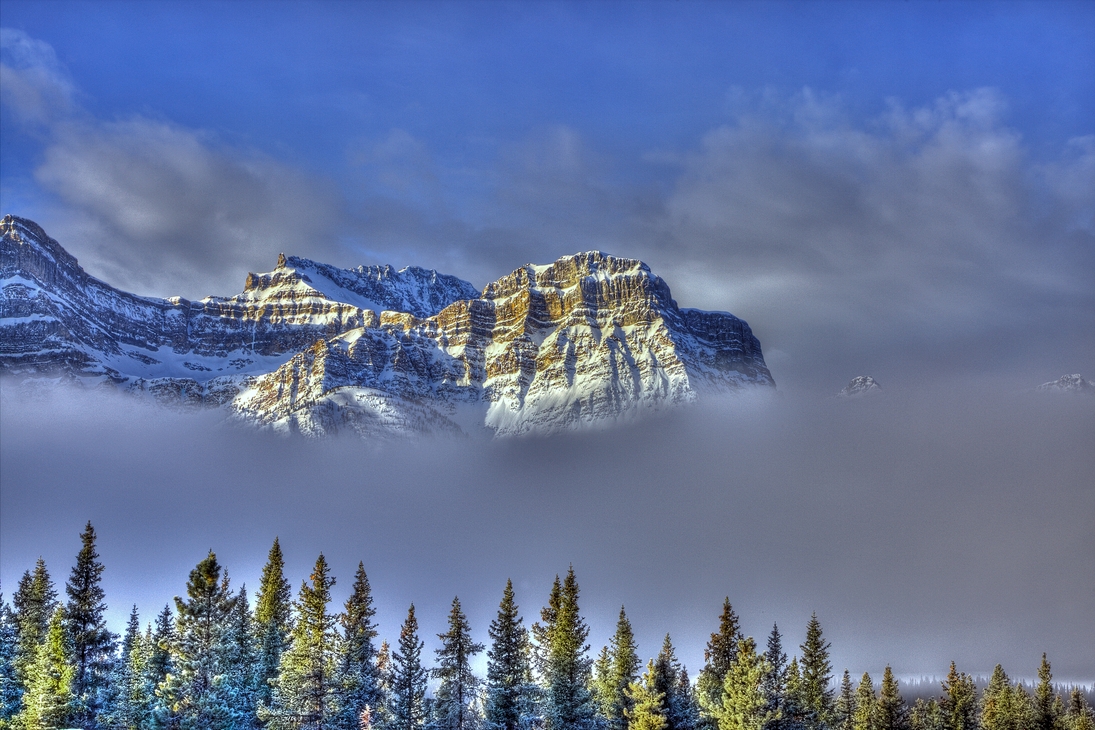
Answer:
485;580;534;730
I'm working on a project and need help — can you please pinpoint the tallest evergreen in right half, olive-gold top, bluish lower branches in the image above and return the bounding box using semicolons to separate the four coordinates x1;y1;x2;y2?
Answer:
542;566;596;730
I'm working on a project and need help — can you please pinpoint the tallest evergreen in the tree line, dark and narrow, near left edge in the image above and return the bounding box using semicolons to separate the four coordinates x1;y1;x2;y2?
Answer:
65;521;117;730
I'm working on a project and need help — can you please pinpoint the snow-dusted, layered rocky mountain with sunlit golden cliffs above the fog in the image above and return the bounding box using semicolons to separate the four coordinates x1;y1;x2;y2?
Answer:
0;216;774;436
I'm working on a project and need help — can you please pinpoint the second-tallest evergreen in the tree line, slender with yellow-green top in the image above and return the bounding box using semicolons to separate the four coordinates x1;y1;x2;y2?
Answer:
255;537;292;705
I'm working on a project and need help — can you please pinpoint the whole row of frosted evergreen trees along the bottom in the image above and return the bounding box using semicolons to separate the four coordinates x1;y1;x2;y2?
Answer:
0;522;1095;730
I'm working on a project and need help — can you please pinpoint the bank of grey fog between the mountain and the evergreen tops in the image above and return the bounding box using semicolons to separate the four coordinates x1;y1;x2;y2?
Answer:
0;381;1095;681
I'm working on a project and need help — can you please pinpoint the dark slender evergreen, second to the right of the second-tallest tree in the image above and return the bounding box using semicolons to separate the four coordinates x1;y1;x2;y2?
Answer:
336;563;382;730
